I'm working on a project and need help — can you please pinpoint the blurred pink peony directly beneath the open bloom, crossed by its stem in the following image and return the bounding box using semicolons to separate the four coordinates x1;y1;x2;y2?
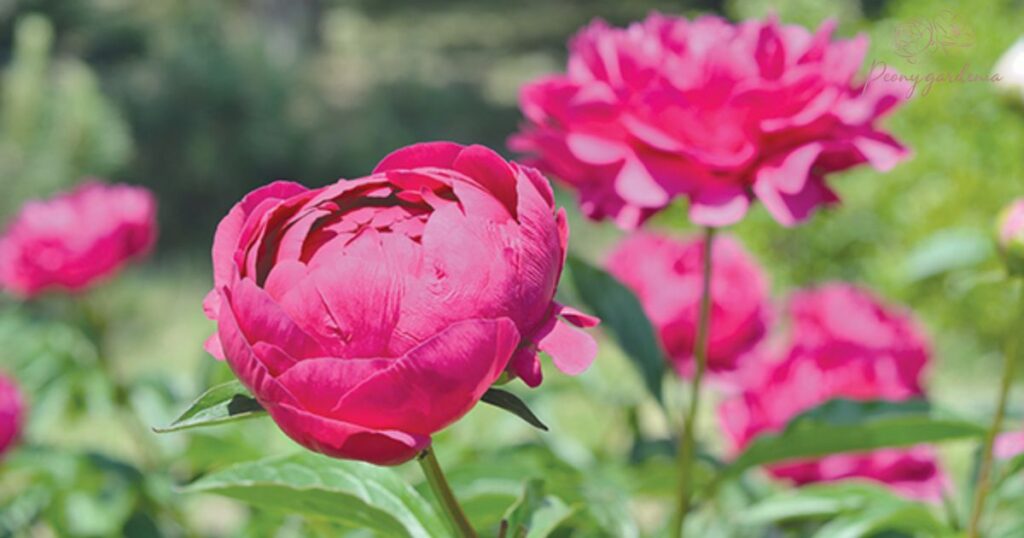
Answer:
607;233;769;375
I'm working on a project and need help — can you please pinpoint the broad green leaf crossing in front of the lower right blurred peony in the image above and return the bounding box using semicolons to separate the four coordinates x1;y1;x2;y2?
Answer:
719;399;985;480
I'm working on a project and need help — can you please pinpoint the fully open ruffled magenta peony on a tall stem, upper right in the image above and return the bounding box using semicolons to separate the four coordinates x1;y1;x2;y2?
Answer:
510;13;907;227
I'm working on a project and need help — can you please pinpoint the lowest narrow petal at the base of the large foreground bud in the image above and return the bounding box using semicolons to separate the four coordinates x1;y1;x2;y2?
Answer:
266;404;430;465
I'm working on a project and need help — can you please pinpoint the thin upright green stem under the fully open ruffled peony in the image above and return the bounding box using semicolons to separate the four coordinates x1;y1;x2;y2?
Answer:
669;227;715;538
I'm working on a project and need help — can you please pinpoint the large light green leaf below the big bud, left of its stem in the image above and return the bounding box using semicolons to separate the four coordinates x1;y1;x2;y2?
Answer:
184;453;451;538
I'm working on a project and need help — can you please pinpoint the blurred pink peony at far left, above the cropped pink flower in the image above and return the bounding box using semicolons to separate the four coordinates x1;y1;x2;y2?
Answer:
0;181;157;297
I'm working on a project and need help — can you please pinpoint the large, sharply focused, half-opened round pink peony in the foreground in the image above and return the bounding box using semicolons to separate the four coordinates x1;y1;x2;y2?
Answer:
205;142;597;464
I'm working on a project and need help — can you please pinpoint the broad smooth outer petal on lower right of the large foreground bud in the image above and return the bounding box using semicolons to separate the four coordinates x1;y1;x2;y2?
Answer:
335;318;519;434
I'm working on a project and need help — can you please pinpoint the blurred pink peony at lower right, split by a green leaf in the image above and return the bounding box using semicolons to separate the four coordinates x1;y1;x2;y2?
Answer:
719;285;947;500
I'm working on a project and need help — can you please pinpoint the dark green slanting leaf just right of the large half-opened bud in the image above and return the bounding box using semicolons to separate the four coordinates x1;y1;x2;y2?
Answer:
568;255;666;402
